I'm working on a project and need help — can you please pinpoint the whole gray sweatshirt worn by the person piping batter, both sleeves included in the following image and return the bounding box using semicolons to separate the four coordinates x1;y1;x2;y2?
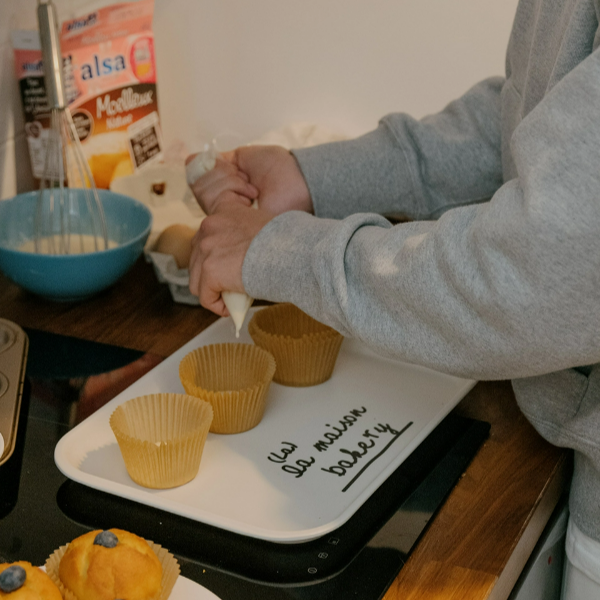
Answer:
243;0;600;541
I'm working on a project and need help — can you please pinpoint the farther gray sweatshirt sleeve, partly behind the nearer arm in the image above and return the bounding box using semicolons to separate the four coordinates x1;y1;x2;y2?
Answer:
293;77;504;219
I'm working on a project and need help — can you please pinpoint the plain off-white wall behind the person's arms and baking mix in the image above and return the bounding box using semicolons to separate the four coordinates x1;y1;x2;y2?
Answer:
0;0;517;198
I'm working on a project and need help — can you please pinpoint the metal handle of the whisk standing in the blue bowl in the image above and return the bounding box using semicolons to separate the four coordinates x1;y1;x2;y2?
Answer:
37;1;67;109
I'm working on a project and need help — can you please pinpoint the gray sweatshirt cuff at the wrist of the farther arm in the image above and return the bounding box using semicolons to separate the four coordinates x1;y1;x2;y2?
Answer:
292;121;416;219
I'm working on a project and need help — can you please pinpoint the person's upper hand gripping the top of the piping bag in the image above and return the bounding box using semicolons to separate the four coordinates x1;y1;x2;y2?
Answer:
186;145;313;215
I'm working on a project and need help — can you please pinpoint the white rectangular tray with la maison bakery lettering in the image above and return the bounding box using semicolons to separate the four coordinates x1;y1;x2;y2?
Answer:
54;308;475;542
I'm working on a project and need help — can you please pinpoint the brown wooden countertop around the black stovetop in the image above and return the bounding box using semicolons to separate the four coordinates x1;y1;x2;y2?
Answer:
0;259;571;600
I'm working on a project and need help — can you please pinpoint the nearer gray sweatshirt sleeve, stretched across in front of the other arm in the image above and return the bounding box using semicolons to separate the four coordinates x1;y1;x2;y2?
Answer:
243;52;600;379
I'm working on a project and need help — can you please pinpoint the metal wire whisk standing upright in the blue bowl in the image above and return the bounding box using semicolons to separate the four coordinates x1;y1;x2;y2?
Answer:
34;0;108;254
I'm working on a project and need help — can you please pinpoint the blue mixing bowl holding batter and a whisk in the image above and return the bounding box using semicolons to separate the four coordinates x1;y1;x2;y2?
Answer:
0;190;152;301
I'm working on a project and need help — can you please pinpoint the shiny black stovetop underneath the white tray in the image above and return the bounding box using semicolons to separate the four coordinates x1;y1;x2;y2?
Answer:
0;330;489;600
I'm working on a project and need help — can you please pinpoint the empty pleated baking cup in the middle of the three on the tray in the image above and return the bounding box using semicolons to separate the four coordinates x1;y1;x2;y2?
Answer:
179;344;275;433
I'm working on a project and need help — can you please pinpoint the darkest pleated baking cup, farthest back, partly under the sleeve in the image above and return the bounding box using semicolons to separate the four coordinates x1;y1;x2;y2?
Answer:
248;303;344;387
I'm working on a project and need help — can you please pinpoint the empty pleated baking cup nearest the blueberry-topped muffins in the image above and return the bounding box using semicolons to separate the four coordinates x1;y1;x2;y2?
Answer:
109;394;213;489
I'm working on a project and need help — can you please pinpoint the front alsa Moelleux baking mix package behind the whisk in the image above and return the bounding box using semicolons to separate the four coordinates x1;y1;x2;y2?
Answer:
60;0;163;189
